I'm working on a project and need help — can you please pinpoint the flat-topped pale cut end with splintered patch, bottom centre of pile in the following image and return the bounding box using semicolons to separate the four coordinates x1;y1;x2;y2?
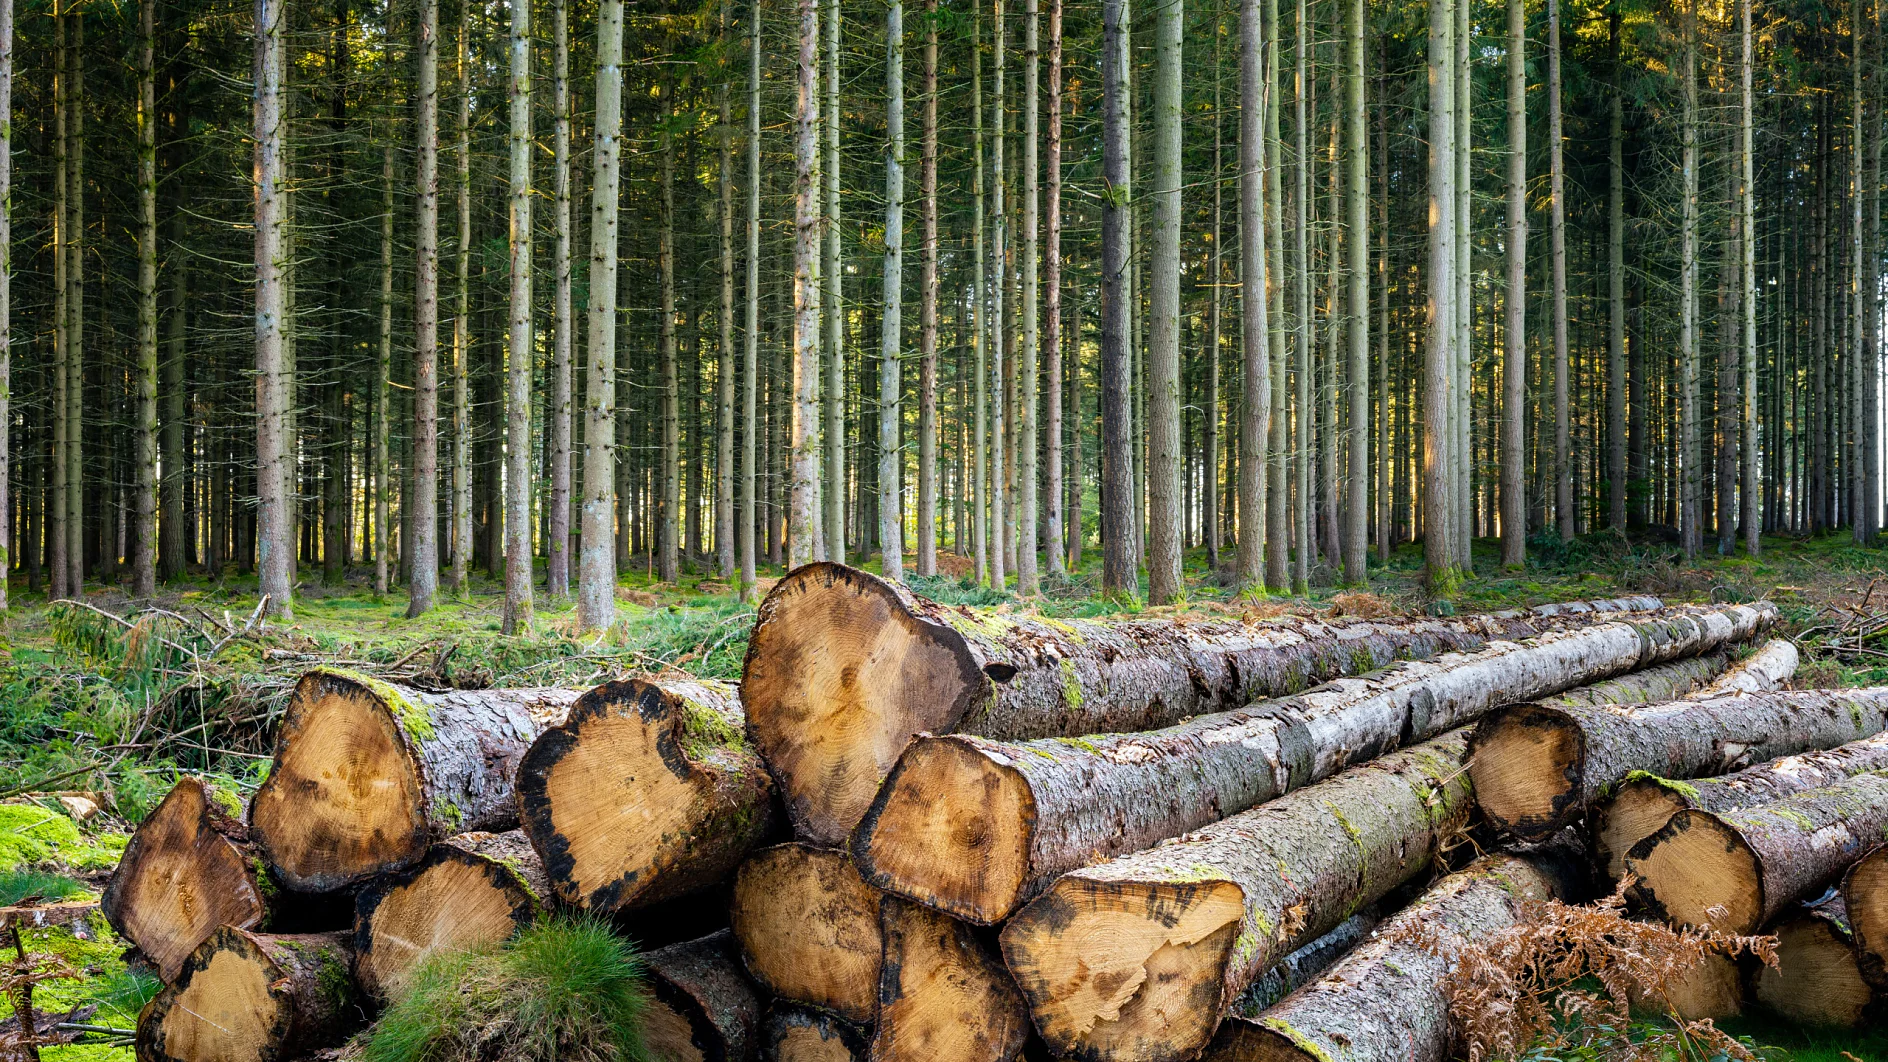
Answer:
1001;875;1246;1062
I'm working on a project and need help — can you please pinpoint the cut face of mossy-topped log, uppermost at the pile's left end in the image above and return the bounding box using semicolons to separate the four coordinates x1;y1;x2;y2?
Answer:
249;671;430;892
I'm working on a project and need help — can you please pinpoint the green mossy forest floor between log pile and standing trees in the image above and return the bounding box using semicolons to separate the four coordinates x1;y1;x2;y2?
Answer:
0;533;1888;1062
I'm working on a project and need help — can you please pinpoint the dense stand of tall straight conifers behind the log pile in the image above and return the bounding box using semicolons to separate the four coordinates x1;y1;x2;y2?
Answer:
0;0;1884;619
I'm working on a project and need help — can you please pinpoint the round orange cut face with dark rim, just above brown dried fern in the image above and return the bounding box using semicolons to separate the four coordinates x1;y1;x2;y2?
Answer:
1626;809;1765;935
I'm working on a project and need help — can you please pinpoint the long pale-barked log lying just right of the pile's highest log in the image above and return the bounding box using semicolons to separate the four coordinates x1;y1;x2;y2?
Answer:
851;605;1775;924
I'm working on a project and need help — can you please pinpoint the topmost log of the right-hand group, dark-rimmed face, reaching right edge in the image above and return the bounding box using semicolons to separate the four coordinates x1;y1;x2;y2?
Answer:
1469;688;1888;841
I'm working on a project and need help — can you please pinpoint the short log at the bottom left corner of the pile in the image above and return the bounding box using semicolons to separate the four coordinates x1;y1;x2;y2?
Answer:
138;926;366;1062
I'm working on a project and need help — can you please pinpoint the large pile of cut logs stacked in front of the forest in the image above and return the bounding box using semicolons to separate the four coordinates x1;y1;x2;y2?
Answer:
106;563;1888;1062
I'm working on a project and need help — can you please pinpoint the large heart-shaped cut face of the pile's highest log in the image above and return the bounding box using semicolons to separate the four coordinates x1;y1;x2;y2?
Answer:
742;561;989;845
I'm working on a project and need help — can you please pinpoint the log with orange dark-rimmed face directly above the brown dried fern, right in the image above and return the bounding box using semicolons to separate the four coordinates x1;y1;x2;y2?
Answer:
1626;773;1888;935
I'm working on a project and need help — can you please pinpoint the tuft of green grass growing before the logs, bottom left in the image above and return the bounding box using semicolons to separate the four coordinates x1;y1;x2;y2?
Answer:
362;918;649;1062
